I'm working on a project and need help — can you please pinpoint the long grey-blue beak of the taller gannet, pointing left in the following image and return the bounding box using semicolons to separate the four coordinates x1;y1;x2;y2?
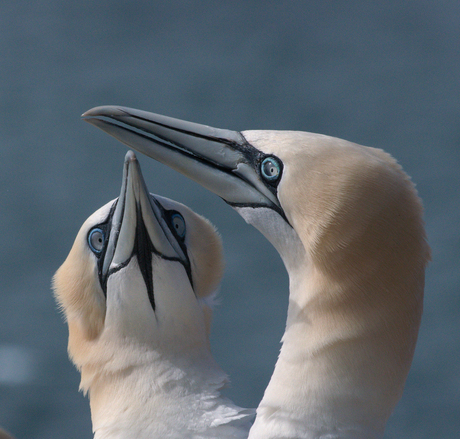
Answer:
82;106;284;216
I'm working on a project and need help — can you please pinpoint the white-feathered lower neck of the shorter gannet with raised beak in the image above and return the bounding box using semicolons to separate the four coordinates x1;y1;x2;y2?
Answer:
82;354;253;439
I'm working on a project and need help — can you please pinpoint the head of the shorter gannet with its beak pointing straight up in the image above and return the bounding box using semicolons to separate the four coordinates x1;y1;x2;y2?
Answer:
53;152;223;390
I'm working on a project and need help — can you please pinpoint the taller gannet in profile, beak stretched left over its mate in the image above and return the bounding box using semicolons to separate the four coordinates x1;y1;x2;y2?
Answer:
83;106;430;439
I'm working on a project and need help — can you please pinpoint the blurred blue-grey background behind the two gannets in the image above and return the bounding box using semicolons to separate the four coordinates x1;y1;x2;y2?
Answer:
0;0;460;439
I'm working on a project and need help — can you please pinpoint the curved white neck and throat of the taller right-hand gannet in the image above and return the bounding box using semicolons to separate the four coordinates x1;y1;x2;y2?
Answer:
239;209;423;439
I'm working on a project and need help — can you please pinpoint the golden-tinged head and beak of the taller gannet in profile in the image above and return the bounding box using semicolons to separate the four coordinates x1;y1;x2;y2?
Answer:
83;106;427;274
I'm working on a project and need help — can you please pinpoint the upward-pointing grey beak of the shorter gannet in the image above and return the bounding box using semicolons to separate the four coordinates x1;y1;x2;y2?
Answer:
98;151;190;296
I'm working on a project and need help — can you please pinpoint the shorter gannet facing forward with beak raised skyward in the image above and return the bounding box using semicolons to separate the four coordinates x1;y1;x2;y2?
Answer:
53;151;255;439
